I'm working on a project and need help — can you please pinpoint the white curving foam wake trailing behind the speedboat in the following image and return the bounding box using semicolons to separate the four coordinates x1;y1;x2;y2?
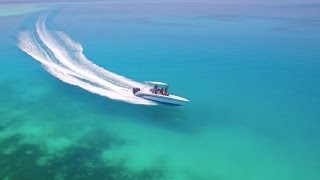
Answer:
18;16;155;105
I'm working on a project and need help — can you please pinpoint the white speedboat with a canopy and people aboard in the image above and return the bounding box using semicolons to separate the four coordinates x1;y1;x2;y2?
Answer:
132;81;189;106
